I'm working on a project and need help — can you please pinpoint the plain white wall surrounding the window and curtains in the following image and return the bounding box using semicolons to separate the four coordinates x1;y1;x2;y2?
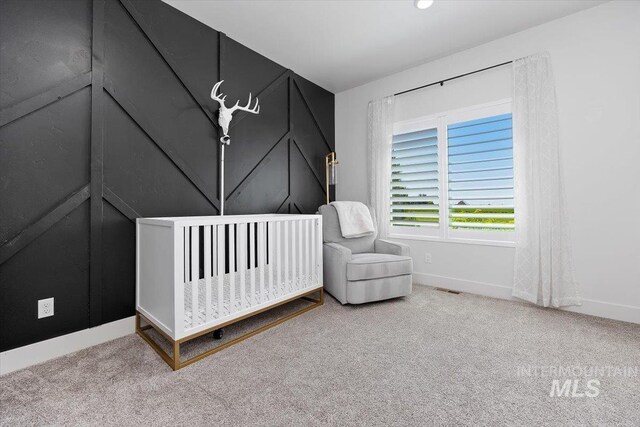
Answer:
336;1;640;323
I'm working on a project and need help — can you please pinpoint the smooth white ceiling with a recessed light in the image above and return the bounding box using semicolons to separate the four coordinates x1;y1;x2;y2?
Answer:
164;0;604;93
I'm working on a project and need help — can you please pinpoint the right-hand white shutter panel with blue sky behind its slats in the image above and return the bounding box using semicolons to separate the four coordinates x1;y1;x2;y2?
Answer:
447;113;514;231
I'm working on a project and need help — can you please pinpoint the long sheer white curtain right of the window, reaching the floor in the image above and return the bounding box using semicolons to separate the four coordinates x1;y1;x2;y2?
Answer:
513;53;581;307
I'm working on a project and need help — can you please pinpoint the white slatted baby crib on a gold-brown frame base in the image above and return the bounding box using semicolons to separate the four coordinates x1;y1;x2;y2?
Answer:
136;214;323;370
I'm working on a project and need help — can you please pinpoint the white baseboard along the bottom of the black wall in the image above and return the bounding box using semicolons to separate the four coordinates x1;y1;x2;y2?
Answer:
0;316;136;375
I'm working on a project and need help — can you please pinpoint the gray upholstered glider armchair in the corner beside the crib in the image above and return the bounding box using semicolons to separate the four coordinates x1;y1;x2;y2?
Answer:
318;205;413;304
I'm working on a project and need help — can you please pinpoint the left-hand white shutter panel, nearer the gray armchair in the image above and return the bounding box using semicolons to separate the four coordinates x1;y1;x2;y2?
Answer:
391;127;440;227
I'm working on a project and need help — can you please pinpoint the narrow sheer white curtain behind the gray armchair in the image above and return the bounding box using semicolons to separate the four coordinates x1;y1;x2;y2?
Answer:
367;96;393;239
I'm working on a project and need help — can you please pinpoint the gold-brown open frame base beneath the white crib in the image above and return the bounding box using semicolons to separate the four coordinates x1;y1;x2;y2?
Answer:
136;288;324;371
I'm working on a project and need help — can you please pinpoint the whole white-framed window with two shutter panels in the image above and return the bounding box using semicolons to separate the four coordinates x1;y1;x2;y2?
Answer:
391;101;515;242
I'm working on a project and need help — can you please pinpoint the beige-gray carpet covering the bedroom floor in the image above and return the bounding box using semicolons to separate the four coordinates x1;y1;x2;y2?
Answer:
0;286;640;427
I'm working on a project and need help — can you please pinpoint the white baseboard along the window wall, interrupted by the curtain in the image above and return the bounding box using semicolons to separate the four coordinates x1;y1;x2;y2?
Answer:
413;273;640;324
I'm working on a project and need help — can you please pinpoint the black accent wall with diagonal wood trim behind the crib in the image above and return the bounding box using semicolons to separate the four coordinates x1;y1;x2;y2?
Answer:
0;0;334;351
